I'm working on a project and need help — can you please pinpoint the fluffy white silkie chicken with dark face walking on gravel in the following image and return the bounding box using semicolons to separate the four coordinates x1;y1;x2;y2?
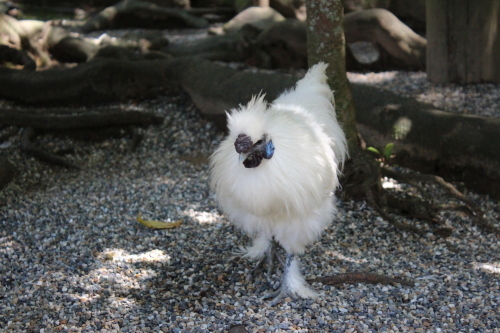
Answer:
210;63;346;304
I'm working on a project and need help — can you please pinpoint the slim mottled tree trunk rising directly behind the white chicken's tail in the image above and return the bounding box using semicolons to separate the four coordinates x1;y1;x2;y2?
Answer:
306;0;358;150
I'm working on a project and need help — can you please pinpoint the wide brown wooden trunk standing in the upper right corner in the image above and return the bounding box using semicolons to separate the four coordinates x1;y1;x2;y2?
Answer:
427;0;500;84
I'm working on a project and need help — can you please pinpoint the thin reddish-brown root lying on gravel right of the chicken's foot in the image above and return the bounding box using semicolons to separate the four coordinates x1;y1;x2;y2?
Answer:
308;272;415;287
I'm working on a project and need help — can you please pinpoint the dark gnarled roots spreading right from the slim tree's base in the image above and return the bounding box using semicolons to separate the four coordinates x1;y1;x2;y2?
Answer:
343;147;500;238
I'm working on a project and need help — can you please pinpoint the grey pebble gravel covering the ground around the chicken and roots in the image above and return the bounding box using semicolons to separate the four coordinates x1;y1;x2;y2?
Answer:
0;27;500;332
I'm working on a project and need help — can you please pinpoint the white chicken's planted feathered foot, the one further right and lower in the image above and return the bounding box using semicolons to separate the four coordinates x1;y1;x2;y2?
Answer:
264;254;318;306
